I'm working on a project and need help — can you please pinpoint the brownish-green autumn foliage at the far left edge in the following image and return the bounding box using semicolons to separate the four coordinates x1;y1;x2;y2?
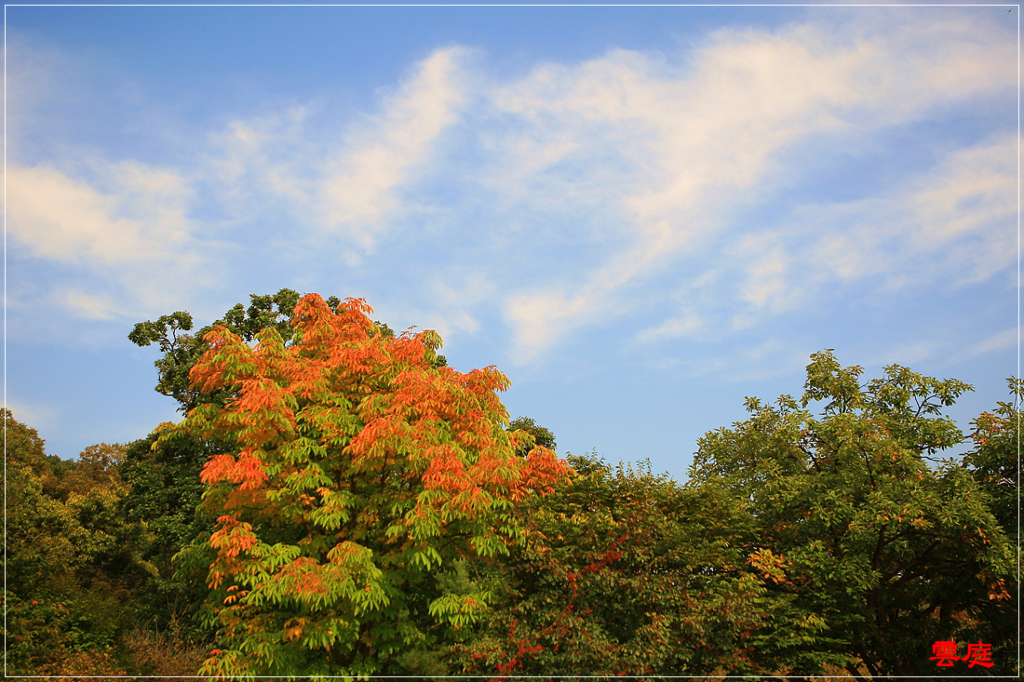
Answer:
4;411;148;675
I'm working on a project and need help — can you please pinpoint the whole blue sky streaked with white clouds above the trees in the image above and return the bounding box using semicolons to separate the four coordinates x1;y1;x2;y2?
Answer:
5;5;1019;478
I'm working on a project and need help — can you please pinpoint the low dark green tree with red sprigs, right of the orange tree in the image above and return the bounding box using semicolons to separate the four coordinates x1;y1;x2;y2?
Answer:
452;456;764;676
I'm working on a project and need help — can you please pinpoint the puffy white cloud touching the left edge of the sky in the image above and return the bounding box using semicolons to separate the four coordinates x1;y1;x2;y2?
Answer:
6;161;215;319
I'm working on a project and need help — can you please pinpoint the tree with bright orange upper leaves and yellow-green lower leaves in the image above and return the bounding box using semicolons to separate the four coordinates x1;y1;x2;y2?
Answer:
162;294;568;676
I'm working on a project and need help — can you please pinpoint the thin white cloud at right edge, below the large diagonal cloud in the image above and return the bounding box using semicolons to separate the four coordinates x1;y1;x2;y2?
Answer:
786;134;1017;290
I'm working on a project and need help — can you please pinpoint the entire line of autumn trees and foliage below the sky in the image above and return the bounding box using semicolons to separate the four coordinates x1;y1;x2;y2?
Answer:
3;290;1022;679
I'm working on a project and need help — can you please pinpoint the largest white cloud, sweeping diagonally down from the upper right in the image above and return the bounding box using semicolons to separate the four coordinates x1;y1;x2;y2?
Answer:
494;14;1013;360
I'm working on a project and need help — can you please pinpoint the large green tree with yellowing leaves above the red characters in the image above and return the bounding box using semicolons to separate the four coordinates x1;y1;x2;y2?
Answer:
691;351;1016;677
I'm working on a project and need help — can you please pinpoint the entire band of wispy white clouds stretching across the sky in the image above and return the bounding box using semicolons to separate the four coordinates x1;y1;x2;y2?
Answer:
8;10;1016;363
